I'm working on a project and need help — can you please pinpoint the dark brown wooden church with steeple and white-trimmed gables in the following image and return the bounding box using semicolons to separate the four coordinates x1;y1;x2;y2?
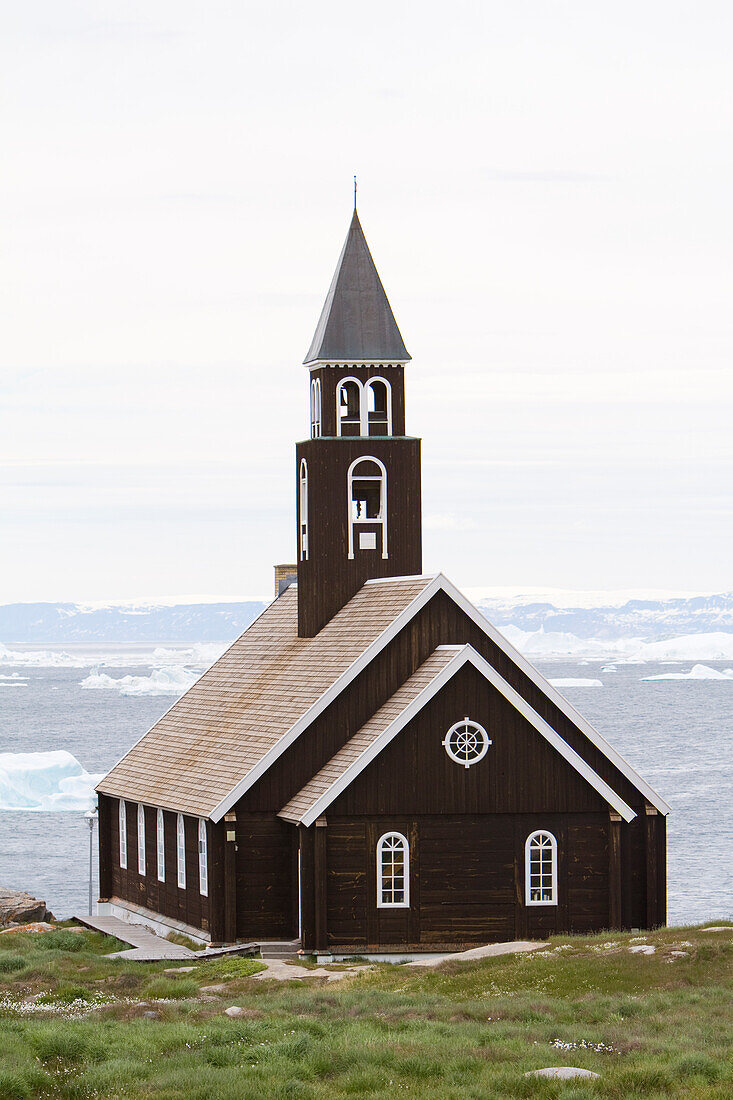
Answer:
98;207;669;955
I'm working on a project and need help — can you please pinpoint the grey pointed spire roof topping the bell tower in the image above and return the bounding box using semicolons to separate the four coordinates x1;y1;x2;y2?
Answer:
303;206;411;364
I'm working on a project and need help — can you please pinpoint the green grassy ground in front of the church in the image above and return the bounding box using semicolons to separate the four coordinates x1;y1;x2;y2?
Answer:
0;925;733;1100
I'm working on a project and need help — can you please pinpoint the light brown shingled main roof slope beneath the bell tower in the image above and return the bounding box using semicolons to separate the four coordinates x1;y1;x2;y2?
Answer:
97;576;434;821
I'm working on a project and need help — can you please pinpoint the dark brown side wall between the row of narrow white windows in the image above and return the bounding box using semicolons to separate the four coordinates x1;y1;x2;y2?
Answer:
105;799;212;934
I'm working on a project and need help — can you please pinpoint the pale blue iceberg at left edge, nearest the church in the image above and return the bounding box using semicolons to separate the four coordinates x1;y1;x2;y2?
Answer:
0;749;105;813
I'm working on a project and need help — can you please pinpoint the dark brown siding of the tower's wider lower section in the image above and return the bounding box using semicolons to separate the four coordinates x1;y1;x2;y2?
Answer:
296;437;423;638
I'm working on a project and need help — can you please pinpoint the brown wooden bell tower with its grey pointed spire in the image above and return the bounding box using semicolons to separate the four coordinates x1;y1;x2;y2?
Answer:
296;204;423;638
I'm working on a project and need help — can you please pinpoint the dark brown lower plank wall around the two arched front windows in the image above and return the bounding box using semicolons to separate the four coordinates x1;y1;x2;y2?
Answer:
314;812;610;952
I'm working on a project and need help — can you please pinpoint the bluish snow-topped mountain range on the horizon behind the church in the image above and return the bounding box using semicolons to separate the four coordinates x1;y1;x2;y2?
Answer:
0;592;733;645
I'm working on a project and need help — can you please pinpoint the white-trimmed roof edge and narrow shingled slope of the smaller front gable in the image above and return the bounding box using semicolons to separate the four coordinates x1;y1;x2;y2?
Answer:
280;645;636;826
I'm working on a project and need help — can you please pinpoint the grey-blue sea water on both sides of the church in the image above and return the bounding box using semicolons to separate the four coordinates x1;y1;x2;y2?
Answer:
0;647;733;924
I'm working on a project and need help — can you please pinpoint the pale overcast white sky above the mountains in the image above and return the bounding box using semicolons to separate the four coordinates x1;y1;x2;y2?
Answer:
0;0;733;603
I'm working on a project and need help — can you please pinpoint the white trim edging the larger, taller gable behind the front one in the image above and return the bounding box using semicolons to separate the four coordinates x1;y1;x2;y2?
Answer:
209;573;669;822
